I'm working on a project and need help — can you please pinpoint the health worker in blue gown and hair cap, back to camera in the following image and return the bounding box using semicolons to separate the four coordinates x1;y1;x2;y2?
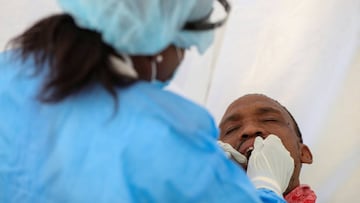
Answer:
0;0;293;203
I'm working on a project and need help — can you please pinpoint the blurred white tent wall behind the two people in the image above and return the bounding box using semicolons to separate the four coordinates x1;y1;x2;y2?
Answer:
0;0;360;203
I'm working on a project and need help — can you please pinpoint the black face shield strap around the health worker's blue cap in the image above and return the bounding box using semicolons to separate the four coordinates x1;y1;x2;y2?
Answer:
183;0;231;31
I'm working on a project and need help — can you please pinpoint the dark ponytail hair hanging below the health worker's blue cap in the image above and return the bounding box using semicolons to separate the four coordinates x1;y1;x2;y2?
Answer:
9;14;135;102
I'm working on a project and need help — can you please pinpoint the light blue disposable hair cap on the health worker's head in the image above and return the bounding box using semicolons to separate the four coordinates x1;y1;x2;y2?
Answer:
58;0;214;55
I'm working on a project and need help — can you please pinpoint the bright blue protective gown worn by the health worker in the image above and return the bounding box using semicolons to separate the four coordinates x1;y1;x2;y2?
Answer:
0;51;285;203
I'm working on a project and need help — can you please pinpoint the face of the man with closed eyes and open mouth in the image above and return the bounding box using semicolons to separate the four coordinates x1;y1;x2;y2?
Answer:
220;94;312;194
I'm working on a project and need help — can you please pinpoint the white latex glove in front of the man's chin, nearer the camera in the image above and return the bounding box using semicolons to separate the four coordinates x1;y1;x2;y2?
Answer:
247;135;294;196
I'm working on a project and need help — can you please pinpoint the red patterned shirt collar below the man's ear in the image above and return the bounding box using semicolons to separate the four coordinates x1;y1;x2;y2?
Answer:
284;185;316;203
